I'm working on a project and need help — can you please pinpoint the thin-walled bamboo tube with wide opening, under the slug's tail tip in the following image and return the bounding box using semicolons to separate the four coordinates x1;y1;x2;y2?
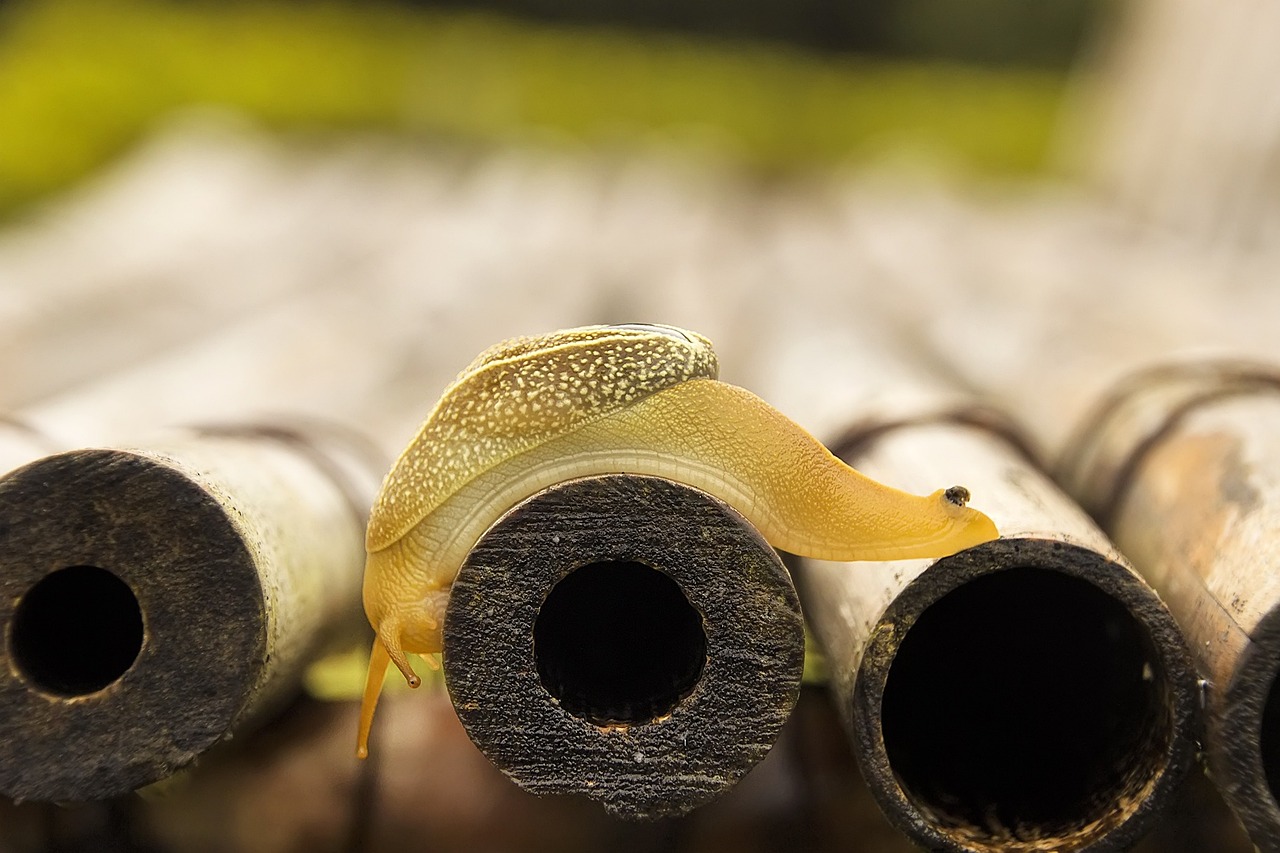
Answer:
797;419;1198;852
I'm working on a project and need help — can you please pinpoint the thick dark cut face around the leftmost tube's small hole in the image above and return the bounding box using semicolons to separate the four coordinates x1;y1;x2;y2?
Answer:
0;450;268;800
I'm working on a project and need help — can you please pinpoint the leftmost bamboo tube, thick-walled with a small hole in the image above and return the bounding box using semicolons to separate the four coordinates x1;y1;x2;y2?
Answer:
0;424;383;800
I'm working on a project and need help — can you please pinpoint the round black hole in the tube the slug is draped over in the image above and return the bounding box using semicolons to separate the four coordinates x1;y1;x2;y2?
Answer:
534;562;707;725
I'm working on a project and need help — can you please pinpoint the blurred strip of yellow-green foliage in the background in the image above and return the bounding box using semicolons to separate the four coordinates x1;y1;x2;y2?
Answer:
0;0;1064;214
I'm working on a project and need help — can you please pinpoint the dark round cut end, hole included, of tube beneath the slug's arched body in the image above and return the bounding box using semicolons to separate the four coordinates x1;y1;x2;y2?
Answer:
444;474;804;818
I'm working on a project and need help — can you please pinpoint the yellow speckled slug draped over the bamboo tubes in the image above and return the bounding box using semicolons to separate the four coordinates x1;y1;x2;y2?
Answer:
357;325;997;757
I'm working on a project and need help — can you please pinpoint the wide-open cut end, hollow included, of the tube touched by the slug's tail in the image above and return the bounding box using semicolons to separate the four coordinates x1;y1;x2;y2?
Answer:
852;539;1192;850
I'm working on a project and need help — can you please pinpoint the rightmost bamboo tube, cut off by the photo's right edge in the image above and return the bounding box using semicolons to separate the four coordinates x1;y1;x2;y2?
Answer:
1062;361;1280;850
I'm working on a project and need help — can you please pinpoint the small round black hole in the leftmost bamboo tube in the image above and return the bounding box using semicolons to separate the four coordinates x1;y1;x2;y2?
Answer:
9;566;142;695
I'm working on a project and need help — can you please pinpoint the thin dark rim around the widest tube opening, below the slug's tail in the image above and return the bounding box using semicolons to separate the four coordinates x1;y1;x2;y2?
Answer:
852;538;1198;852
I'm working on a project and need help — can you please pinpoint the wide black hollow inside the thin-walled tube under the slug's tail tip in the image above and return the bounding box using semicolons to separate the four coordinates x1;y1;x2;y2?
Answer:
882;567;1172;844
